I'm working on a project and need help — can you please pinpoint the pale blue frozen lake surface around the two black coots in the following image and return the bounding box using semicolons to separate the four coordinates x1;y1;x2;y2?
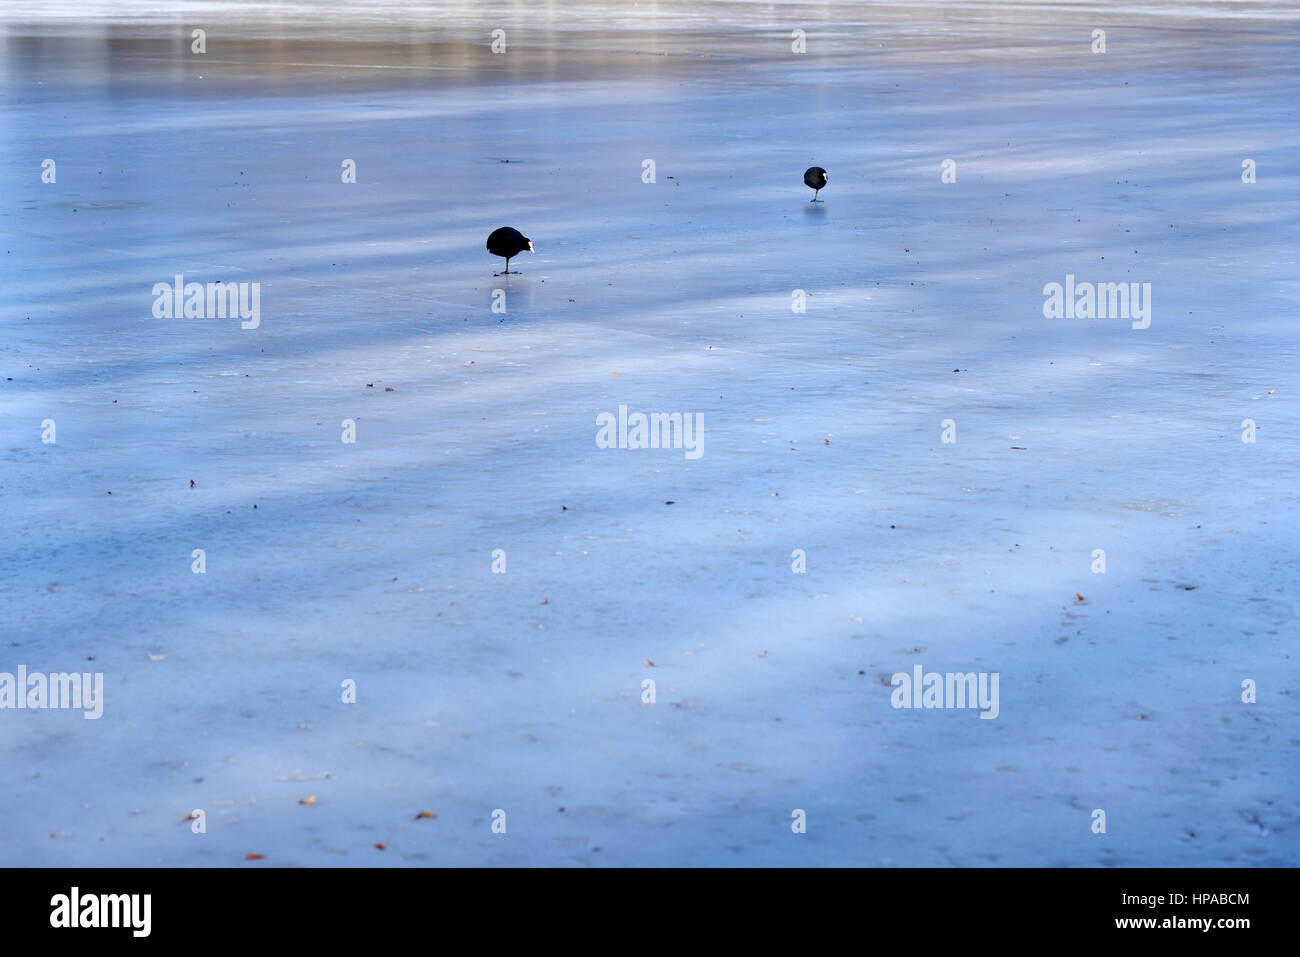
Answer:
0;0;1300;866
